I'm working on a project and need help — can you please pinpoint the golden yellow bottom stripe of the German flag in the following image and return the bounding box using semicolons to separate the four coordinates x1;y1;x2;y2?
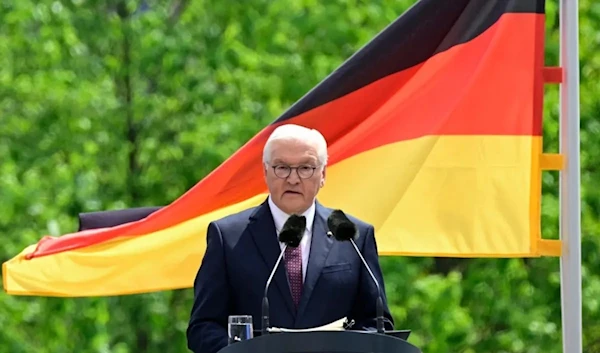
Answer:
3;136;560;296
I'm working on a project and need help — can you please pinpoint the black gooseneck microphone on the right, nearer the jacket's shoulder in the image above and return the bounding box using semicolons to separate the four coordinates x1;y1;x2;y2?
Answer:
327;210;385;333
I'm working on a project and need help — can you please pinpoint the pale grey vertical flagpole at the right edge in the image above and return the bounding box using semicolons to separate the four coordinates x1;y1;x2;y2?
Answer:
559;0;583;353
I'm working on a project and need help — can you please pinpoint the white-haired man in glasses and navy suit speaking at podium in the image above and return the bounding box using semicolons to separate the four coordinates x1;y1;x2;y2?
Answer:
187;124;393;353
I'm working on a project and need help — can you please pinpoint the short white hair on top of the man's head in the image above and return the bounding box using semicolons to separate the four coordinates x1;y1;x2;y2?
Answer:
263;124;327;166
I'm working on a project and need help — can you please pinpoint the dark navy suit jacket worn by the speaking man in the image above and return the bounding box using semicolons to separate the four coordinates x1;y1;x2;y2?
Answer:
187;201;393;353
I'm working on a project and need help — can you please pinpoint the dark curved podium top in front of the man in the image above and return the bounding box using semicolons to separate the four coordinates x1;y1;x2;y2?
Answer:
219;331;422;353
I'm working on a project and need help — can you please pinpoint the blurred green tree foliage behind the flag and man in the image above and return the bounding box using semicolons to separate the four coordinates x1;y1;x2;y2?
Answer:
0;0;600;353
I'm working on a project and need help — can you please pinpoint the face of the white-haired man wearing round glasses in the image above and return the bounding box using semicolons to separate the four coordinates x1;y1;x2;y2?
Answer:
265;140;325;214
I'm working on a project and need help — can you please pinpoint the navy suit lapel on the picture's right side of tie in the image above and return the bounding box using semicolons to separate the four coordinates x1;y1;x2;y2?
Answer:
296;202;333;322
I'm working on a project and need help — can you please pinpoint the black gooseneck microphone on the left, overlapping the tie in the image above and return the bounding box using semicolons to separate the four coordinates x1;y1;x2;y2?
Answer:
262;214;306;335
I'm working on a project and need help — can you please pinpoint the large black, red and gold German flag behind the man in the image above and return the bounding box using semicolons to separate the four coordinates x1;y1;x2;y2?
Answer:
3;0;560;296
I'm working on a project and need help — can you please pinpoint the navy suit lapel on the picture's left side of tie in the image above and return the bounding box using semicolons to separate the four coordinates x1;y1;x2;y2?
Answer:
248;201;296;316
